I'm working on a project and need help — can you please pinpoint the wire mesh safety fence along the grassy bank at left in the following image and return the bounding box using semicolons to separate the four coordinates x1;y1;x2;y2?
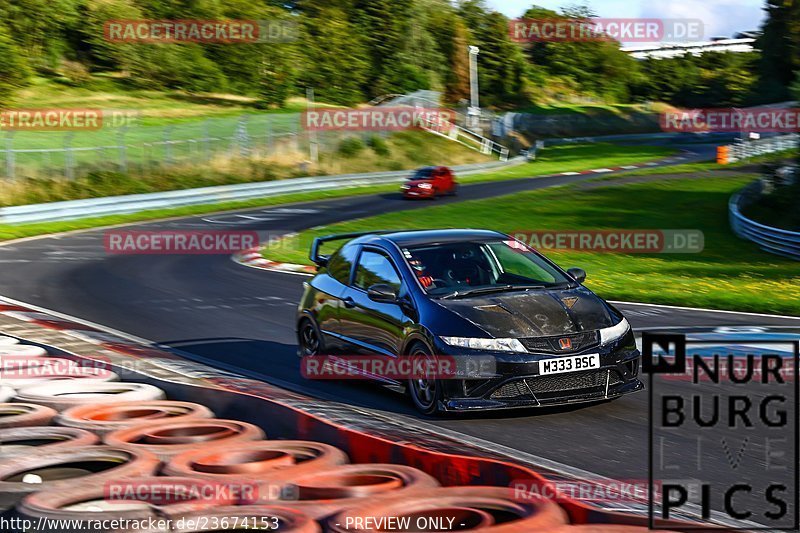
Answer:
0;113;396;179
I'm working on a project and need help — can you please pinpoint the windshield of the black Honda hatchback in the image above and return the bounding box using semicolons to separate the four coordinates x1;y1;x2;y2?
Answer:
403;240;574;298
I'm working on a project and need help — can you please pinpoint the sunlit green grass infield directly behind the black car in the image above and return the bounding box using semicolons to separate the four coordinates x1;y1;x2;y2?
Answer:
265;175;800;315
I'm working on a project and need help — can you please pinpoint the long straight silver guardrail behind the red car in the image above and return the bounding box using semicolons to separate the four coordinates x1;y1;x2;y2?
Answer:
0;158;524;224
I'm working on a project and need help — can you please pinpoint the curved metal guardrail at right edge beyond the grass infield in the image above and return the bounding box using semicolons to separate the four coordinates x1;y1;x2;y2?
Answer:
728;181;800;261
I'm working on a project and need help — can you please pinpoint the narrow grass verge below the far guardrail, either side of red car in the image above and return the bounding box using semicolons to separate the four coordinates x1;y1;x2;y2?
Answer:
0;141;680;241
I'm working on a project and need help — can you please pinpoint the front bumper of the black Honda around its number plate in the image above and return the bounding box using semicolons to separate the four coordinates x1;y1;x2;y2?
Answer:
437;332;644;411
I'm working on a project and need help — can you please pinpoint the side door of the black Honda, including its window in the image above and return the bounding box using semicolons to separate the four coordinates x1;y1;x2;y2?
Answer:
339;247;410;357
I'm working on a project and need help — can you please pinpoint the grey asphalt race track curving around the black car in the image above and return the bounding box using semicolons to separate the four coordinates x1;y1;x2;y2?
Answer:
0;145;800;508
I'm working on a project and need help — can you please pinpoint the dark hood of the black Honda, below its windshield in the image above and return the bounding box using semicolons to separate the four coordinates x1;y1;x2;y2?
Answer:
437;287;619;338
